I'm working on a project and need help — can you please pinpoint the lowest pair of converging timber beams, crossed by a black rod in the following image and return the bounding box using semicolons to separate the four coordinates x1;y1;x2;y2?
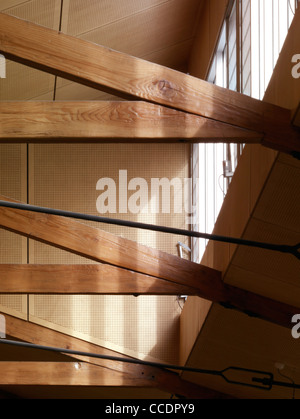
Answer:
0;314;229;399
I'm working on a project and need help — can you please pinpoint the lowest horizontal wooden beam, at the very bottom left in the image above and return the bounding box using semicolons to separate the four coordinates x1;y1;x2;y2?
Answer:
0;361;232;399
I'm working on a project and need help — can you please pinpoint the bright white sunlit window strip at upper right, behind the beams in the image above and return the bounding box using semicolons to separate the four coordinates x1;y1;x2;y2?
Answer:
192;0;299;262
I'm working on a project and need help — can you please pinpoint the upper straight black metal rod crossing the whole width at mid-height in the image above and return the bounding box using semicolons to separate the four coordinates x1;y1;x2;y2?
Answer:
0;200;300;260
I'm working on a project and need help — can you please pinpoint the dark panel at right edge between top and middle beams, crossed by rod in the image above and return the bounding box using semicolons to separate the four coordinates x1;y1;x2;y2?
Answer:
225;155;300;306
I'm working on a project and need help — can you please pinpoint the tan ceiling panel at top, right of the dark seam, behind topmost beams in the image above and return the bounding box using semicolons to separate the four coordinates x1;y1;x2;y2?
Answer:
56;0;199;100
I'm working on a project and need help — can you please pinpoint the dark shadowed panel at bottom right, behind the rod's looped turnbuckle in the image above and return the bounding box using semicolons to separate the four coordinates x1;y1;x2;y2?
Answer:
182;304;300;399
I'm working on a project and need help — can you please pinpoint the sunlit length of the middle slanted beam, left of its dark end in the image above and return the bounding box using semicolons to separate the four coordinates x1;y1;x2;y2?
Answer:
0;196;221;289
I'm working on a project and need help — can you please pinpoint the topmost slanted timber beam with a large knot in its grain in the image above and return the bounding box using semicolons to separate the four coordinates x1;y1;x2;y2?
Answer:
0;13;300;158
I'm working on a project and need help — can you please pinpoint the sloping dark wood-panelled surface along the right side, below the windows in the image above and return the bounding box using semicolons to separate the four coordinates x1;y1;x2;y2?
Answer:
181;7;300;399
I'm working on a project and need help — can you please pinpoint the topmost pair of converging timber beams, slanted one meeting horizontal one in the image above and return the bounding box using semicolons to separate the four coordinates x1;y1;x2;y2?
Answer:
0;13;300;153
